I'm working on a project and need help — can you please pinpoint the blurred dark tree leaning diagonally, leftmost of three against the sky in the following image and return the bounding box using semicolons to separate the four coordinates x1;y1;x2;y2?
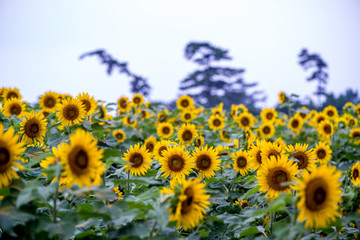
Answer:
80;49;151;96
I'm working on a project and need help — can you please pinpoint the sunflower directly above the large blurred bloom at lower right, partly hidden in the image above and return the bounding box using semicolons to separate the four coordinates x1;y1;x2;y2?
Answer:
286;143;316;172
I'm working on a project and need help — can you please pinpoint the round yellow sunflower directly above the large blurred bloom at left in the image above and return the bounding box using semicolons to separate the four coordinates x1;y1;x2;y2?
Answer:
56;98;86;126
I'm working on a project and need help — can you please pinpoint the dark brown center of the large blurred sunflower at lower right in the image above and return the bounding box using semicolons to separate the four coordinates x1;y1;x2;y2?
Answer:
305;178;327;211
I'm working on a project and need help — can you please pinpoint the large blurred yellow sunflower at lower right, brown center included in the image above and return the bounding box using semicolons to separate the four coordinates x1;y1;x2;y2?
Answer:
295;165;342;228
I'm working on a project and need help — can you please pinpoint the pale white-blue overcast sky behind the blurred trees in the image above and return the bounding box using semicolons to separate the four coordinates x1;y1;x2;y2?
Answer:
0;0;360;106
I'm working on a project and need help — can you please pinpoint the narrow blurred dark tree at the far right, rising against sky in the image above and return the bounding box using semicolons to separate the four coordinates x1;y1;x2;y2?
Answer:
299;49;329;106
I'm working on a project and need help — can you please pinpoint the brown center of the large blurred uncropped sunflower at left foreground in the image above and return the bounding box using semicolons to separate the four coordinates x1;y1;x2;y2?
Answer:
69;146;89;175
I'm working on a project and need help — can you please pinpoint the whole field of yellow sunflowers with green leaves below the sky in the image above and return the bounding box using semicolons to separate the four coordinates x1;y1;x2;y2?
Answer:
0;87;360;240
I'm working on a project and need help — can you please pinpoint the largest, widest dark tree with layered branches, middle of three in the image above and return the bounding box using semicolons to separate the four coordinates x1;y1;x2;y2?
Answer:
180;42;264;109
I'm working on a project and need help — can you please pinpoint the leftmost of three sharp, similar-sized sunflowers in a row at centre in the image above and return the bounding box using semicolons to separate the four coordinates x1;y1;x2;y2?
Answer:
123;143;152;176
